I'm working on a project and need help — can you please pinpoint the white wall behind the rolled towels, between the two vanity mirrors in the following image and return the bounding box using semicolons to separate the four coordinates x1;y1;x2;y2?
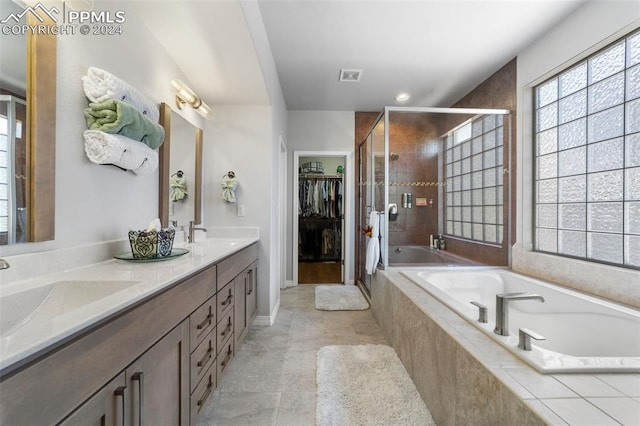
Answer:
2;1;202;255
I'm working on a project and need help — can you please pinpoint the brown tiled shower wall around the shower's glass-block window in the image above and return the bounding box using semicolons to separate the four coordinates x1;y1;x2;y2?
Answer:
356;58;516;265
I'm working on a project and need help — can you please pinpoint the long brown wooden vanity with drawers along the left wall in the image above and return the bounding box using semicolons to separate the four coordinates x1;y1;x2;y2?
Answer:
0;241;258;425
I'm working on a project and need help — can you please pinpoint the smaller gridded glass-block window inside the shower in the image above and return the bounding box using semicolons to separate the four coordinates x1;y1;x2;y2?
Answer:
445;115;504;244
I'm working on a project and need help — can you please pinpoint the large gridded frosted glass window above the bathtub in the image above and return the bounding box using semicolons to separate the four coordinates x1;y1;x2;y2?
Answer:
534;31;640;268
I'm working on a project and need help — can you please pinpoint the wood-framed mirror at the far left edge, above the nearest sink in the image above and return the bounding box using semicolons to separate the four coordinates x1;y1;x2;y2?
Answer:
0;1;56;245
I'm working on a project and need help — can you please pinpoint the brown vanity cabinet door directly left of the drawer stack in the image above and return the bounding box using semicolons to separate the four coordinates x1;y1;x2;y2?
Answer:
126;320;189;426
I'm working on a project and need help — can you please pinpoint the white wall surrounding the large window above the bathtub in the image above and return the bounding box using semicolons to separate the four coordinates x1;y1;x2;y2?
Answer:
513;1;640;306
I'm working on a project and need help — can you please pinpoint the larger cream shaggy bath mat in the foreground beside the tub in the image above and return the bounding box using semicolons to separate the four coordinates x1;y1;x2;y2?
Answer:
316;345;435;426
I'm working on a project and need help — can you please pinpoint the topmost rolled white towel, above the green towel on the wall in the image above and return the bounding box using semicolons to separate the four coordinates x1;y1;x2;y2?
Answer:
82;67;160;123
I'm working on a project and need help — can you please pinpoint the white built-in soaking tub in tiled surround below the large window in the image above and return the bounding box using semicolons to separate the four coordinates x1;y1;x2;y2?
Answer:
402;268;640;373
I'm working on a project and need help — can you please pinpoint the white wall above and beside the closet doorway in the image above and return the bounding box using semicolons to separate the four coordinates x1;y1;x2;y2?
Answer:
287;111;355;281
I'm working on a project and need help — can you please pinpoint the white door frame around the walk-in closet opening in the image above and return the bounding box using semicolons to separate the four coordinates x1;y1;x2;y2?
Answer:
291;151;355;286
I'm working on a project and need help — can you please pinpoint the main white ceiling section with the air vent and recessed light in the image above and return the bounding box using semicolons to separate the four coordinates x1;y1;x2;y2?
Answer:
258;0;583;111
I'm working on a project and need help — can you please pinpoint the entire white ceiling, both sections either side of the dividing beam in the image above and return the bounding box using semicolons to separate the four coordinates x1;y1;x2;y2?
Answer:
123;0;585;111
